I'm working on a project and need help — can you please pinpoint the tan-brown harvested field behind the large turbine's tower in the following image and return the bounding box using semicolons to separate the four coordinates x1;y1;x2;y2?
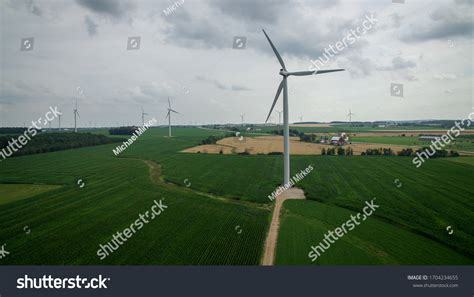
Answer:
182;136;414;155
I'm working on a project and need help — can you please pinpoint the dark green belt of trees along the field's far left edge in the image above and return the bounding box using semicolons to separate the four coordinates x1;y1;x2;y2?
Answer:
0;133;125;156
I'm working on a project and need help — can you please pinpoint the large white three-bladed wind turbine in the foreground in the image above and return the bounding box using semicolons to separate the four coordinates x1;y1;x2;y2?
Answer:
262;29;344;185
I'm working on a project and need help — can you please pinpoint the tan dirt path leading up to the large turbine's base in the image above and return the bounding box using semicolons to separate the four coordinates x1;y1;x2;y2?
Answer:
262;188;305;266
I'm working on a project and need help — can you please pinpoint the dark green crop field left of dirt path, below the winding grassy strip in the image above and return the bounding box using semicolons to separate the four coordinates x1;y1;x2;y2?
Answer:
0;129;269;265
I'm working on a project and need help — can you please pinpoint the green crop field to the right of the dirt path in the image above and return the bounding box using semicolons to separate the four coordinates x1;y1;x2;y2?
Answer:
277;157;474;264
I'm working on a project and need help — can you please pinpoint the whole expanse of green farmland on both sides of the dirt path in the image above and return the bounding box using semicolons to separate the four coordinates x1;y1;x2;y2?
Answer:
0;128;474;265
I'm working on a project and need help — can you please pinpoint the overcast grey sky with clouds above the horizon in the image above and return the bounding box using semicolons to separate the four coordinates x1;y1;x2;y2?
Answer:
0;0;473;127
